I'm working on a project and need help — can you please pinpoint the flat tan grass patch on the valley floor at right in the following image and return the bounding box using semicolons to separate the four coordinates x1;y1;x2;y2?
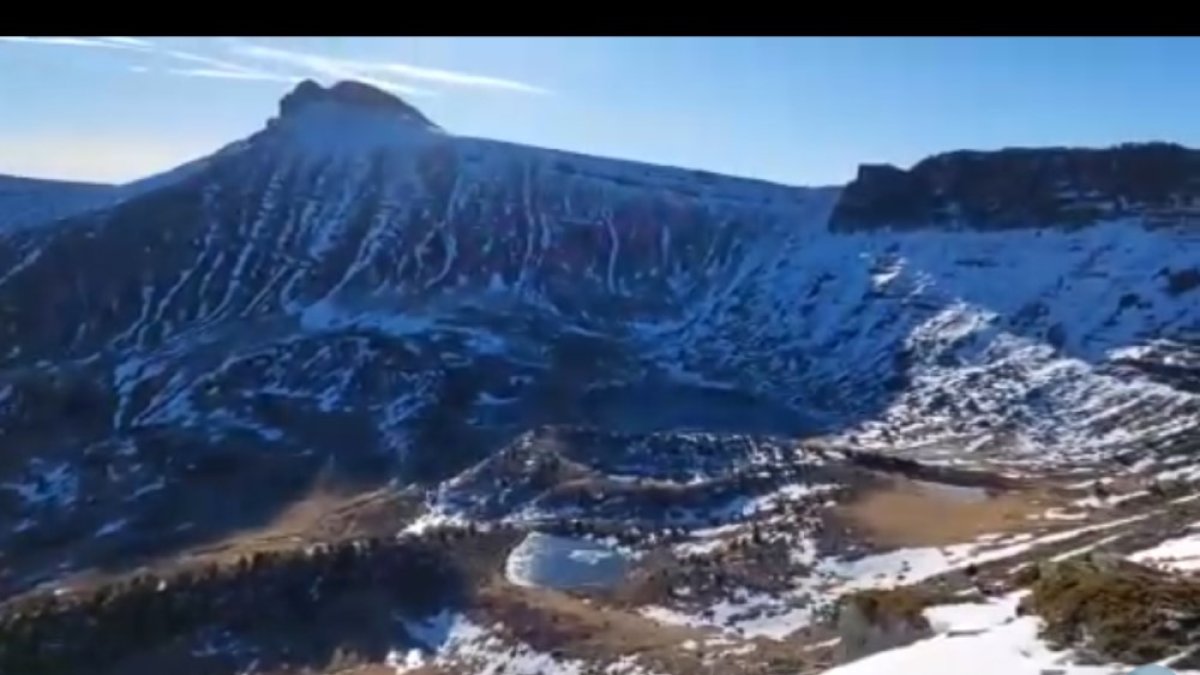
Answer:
834;478;1056;546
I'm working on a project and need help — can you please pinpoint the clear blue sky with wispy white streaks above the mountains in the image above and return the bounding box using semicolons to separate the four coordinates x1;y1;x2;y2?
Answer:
0;37;1200;185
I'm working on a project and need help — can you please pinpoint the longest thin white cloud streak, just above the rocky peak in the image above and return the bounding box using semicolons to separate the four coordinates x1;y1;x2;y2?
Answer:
233;44;550;94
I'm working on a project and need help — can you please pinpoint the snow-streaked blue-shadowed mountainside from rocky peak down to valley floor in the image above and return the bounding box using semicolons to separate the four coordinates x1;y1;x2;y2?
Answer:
0;78;1200;590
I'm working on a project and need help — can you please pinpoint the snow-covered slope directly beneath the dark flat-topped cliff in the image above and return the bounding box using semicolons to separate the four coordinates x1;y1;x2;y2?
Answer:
659;222;1200;461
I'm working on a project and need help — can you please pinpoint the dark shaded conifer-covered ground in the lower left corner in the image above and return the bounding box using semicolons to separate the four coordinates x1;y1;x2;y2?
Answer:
0;530;506;675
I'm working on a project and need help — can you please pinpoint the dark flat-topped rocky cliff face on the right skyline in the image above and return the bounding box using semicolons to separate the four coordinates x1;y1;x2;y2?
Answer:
832;143;1200;231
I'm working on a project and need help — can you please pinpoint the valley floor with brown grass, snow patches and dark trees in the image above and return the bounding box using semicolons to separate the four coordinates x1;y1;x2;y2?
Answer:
9;436;1200;675
